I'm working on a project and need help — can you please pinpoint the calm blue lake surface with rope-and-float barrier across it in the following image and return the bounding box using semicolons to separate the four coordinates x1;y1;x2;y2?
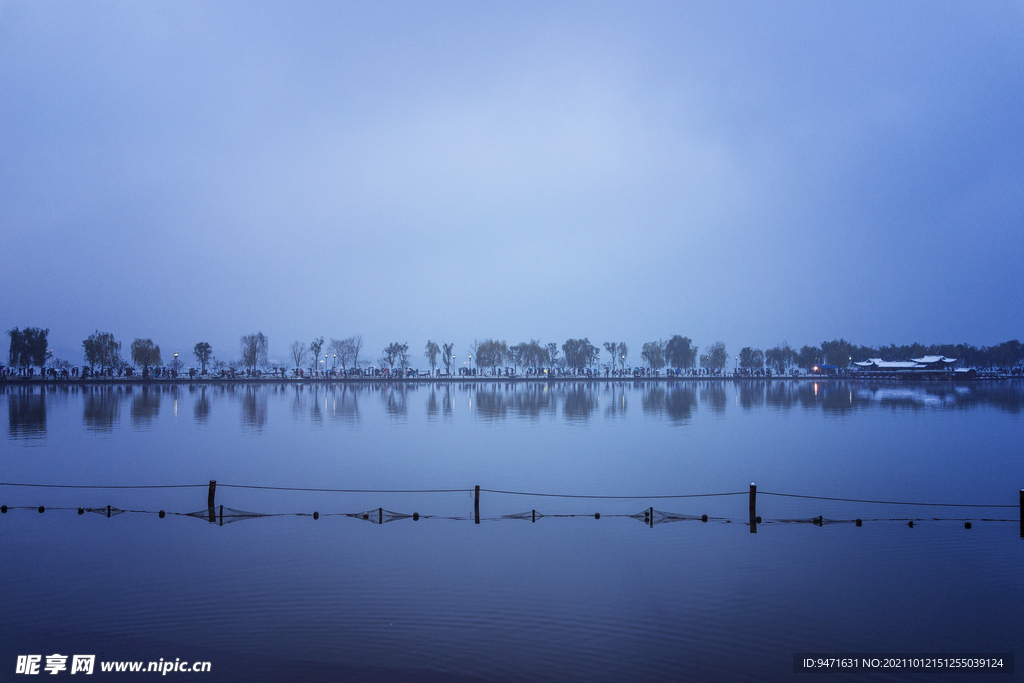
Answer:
0;380;1024;681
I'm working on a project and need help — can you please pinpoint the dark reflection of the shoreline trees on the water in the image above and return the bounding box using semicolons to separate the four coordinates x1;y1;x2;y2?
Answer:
0;380;1024;437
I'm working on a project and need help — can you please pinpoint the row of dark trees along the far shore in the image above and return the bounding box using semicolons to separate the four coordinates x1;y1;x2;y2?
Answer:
6;327;1024;381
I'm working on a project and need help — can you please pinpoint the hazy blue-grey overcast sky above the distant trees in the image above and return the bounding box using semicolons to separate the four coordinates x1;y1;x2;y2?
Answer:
0;0;1024;362
